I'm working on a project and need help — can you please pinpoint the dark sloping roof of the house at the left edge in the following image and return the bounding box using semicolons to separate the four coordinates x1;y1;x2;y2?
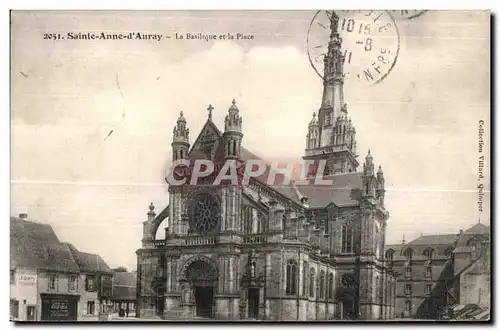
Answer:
10;217;79;273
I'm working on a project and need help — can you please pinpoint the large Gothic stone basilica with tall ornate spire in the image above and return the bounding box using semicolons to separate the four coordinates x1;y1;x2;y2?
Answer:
136;15;396;321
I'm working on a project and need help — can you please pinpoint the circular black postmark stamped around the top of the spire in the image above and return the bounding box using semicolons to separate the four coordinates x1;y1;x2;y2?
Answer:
307;10;400;85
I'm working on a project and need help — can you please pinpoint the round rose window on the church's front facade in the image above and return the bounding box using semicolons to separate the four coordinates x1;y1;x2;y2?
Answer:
188;193;220;234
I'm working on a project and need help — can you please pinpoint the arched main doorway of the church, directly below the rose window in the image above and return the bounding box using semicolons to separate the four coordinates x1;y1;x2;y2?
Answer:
186;260;217;318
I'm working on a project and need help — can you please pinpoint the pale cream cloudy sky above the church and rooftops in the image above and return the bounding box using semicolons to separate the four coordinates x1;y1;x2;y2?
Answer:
10;11;490;269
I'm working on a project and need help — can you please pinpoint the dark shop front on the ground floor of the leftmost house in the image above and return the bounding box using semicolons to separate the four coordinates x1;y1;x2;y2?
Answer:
41;294;79;321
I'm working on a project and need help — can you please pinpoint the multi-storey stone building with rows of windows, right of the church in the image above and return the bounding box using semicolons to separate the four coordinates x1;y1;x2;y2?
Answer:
385;223;491;319
